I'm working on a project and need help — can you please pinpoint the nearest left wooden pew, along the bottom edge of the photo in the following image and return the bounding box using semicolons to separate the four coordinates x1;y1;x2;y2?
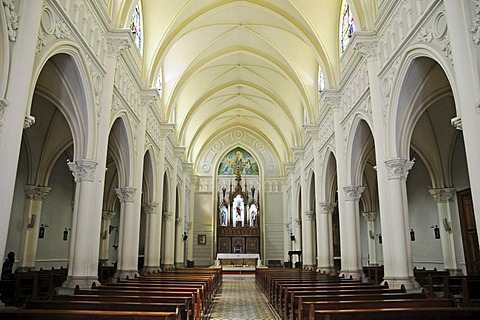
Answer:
0;308;179;320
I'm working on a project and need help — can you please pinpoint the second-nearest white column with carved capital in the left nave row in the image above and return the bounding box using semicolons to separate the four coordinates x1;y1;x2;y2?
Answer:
115;187;140;279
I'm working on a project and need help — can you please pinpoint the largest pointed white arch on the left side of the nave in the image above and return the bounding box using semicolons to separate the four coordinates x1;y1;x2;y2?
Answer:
30;40;97;159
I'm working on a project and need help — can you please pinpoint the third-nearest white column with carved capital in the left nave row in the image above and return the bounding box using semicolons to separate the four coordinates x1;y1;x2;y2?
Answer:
142;202;161;273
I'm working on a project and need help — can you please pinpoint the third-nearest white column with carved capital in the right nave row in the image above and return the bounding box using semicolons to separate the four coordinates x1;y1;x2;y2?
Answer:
317;202;336;274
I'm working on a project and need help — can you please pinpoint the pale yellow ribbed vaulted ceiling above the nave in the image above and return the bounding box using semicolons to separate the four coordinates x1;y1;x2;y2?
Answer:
109;0;377;174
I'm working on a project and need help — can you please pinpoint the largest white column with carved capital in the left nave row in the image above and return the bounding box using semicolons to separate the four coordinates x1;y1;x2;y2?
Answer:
63;159;100;288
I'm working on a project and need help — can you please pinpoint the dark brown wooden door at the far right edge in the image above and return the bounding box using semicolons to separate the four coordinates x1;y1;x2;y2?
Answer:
457;189;480;276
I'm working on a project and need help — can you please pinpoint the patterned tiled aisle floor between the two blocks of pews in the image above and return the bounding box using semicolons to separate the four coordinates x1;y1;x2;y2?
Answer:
206;275;280;320
